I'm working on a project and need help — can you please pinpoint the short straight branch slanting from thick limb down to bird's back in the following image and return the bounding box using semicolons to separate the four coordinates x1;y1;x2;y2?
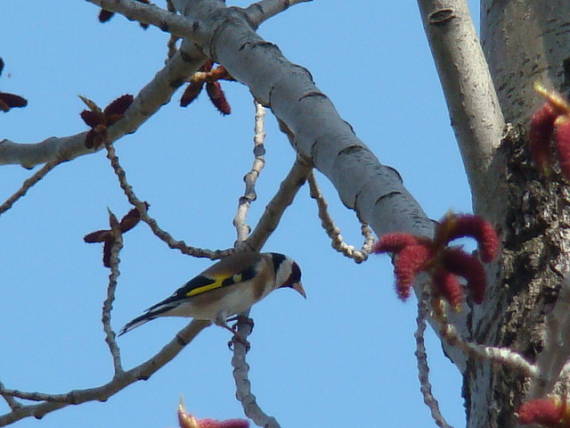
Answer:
245;159;311;251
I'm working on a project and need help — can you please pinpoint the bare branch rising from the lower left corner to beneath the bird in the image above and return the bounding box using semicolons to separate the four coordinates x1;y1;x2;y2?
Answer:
0;320;210;426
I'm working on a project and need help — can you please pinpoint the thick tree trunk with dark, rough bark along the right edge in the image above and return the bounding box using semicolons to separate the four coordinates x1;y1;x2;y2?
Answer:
464;0;570;428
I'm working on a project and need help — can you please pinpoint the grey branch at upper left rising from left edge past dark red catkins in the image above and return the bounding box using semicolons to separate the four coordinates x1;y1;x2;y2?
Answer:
0;41;205;168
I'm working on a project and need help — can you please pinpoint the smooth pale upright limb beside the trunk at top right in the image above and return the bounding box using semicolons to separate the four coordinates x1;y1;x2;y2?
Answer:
412;0;505;213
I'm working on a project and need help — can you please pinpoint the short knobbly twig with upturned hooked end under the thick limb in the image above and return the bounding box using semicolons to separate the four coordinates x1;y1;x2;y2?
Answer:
308;172;374;263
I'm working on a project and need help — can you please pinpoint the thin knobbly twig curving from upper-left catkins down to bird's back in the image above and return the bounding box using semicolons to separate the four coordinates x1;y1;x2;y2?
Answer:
105;143;233;259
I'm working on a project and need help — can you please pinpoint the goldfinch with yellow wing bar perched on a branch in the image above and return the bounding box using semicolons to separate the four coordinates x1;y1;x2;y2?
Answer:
119;252;307;336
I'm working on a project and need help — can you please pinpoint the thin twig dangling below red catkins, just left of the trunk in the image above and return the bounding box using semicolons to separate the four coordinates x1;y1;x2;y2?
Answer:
414;290;453;428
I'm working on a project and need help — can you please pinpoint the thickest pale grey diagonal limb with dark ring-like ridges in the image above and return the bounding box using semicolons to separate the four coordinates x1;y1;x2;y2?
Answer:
173;0;433;242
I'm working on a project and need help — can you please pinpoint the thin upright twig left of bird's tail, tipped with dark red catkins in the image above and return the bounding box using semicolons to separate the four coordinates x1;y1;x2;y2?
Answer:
101;211;123;376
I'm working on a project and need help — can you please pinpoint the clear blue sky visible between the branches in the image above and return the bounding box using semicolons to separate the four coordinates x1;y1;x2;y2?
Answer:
0;0;479;428
